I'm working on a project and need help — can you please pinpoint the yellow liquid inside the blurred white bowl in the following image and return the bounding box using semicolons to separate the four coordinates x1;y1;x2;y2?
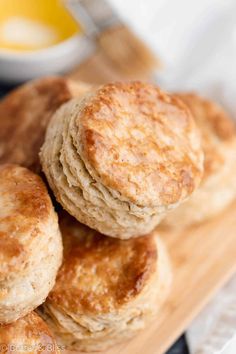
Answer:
0;0;81;52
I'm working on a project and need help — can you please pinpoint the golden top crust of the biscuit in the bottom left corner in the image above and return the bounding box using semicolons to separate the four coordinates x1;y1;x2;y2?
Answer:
0;312;59;354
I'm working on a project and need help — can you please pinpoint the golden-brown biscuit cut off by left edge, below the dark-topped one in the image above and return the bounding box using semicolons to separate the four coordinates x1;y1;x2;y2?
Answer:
0;165;62;324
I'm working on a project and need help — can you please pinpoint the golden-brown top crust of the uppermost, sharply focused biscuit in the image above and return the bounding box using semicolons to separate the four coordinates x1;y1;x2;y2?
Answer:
76;82;203;207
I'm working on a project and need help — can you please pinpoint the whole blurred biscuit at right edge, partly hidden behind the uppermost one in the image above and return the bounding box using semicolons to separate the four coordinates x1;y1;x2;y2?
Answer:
163;93;236;227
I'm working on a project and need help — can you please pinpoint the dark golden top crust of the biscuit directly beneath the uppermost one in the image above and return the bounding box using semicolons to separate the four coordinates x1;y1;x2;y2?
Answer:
48;216;157;314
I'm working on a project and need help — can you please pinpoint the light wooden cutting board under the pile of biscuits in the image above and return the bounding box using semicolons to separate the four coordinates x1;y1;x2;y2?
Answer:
65;53;236;354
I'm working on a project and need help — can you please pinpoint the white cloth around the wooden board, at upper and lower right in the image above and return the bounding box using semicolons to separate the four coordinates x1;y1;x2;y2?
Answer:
110;0;236;354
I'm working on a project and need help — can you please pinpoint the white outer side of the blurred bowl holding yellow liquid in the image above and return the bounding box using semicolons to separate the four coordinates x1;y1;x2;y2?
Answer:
0;34;93;83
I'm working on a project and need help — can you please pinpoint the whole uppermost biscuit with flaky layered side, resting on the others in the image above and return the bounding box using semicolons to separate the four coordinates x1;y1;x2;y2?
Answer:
41;82;203;239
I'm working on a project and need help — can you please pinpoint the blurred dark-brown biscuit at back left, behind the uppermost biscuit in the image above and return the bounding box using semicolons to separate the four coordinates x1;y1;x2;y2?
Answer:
0;77;90;172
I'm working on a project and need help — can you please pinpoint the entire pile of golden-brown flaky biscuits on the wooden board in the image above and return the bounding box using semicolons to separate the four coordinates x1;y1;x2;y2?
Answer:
0;77;236;353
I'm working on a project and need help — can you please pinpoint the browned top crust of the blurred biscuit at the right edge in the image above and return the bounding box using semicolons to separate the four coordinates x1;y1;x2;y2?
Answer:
177;93;236;180
